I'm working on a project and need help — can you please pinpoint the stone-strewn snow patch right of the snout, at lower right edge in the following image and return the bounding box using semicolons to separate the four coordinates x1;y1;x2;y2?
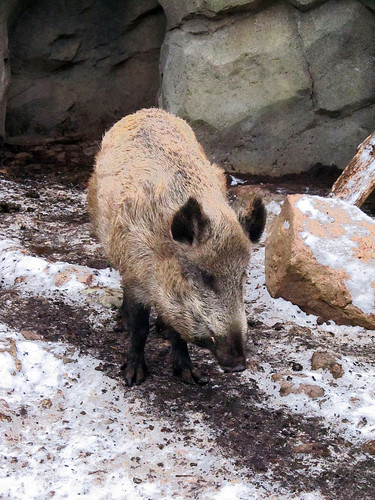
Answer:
243;350;375;442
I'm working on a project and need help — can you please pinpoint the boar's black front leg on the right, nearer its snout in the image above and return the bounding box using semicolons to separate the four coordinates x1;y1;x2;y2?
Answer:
168;330;207;384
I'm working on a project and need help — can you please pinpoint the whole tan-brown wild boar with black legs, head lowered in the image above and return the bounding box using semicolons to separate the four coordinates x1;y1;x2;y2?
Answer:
88;109;265;386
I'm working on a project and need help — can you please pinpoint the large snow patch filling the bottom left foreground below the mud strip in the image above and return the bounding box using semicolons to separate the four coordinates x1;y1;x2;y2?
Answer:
0;324;321;500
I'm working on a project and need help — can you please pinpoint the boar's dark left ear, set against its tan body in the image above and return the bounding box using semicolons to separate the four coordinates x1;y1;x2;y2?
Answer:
171;197;210;245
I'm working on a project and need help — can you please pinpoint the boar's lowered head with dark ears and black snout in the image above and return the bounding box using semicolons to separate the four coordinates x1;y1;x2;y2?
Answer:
158;197;265;371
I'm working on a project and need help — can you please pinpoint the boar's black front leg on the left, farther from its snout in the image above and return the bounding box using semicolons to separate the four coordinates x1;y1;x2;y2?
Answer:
122;300;150;387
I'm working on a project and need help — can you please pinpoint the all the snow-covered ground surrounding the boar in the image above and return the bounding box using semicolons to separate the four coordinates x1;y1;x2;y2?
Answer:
0;174;375;500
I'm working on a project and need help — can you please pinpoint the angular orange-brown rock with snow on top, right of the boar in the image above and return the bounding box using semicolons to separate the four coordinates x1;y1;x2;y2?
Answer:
265;195;375;329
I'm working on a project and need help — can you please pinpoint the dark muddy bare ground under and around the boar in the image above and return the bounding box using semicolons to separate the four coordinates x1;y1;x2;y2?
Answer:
0;143;375;500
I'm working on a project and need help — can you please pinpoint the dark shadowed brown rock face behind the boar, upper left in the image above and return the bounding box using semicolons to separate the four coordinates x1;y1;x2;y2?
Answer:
7;0;165;142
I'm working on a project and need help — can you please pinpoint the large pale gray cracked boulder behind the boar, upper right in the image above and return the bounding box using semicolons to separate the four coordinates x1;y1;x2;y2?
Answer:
159;0;375;175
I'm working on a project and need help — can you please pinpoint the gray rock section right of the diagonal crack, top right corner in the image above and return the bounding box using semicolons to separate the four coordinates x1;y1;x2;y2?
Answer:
298;0;375;117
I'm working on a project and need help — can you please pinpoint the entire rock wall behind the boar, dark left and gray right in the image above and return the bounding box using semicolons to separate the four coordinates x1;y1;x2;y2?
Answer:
0;0;375;175
